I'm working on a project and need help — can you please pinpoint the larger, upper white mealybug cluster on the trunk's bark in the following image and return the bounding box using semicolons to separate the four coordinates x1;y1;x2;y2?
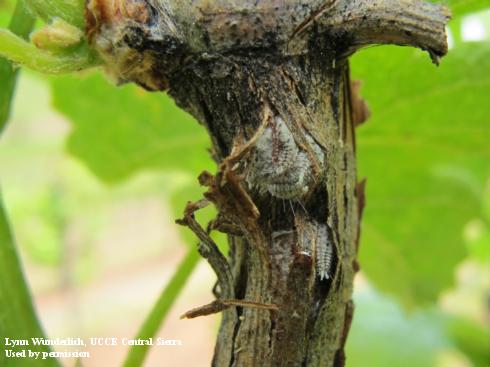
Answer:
247;116;324;199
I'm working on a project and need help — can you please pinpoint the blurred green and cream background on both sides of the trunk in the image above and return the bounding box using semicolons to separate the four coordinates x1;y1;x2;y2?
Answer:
0;0;490;367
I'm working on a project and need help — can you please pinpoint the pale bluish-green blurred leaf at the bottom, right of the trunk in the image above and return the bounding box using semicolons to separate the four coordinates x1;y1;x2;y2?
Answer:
346;289;451;367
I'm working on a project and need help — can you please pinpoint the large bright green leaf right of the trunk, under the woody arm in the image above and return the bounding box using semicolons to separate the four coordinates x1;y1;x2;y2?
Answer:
352;43;490;306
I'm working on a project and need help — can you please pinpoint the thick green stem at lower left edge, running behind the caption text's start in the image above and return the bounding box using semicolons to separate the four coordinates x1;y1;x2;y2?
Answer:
0;191;60;367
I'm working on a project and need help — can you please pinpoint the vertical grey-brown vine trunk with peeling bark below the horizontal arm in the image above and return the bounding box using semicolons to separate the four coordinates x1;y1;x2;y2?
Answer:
170;54;362;366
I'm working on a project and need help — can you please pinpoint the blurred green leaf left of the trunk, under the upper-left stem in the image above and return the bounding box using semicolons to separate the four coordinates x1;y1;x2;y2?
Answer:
52;74;213;183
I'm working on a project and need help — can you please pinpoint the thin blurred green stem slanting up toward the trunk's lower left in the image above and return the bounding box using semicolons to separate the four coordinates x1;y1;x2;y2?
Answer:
124;250;200;367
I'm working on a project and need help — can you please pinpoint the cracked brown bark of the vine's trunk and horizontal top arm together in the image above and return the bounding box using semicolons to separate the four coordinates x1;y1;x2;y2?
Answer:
87;0;449;367
